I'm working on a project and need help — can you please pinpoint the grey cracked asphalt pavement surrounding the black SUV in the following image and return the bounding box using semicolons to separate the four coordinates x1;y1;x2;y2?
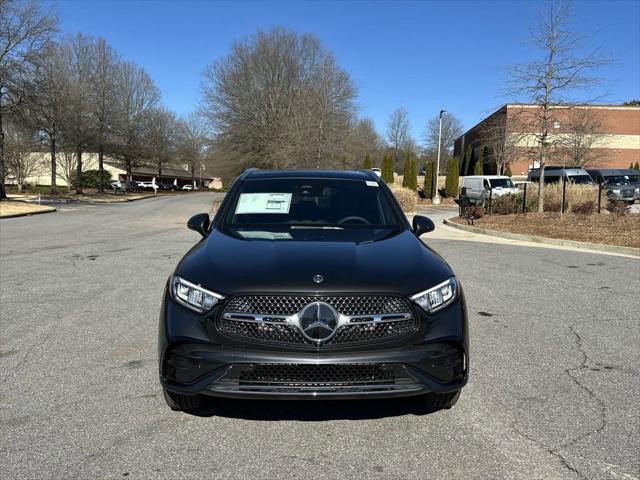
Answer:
0;193;640;479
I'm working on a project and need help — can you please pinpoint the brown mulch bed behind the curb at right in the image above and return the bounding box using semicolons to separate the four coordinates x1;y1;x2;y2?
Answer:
453;213;640;248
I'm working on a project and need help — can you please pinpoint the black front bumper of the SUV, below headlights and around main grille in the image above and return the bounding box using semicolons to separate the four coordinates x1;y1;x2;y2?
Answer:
159;284;469;399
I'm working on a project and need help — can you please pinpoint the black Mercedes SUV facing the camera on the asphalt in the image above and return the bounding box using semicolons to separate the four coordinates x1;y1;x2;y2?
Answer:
159;169;469;410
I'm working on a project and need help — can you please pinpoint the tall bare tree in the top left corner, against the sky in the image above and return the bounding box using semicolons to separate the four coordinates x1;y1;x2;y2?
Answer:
0;0;57;200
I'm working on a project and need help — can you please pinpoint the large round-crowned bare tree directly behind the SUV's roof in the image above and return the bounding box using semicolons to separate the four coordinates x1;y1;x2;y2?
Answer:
201;28;355;172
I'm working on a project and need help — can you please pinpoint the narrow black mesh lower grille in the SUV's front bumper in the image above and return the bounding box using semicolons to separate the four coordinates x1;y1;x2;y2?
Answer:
239;363;395;386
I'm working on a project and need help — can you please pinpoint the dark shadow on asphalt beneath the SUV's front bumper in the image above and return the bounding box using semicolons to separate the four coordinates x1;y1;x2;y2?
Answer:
189;397;442;422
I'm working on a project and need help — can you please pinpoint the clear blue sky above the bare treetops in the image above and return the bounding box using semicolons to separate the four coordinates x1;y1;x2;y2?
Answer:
51;0;640;141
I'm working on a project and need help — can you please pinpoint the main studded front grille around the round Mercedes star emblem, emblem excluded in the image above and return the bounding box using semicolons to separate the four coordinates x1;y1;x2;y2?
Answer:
218;295;417;347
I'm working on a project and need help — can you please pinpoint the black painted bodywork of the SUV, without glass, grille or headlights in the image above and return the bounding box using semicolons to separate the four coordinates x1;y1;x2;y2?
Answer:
158;171;469;398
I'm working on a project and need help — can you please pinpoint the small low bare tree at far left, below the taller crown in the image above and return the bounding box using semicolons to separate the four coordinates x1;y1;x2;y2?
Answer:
5;119;43;193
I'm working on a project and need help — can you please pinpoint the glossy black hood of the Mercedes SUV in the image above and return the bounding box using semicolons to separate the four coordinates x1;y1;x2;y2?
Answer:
176;230;452;296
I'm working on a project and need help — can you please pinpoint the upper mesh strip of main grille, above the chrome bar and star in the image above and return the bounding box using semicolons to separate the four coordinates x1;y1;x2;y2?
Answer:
225;295;411;315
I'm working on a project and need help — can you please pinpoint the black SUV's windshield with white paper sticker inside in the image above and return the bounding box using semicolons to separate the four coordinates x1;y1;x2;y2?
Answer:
225;178;399;229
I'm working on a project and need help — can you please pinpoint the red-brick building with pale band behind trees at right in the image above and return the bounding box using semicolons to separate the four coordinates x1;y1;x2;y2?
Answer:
454;104;640;175
